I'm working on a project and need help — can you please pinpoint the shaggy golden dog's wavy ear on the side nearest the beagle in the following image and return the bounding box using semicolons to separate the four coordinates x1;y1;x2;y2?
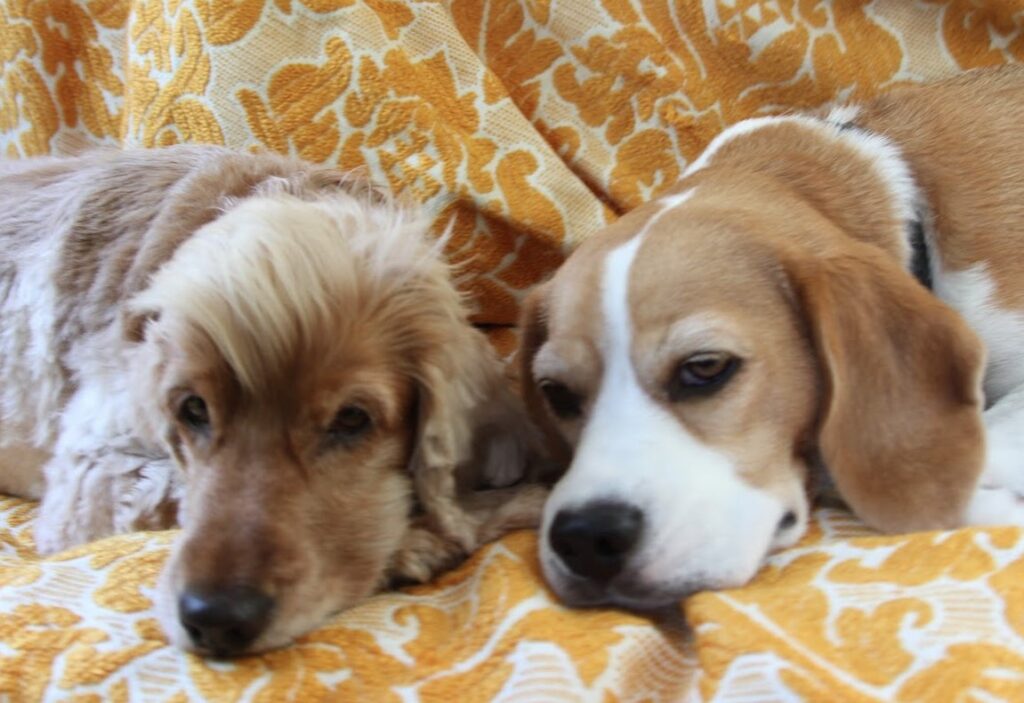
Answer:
412;296;540;552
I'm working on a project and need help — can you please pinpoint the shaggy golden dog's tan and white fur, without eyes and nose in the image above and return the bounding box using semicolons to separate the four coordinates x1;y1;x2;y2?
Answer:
0;147;543;651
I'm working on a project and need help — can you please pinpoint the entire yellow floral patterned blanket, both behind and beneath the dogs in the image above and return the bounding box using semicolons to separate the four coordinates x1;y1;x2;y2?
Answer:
0;0;1024;702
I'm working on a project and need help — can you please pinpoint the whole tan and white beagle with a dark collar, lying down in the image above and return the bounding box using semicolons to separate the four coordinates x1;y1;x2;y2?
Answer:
520;67;1024;609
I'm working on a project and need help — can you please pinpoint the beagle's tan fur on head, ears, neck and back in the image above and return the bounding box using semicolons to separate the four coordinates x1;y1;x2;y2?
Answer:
520;67;1024;573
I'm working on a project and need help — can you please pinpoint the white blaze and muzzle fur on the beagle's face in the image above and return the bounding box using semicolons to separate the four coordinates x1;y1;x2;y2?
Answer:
542;190;784;606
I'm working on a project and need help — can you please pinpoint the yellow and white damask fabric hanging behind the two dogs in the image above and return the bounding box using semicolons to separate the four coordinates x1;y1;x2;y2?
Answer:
6;0;1024;324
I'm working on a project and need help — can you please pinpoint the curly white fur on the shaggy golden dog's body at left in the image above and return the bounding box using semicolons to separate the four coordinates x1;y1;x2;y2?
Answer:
0;186;187;553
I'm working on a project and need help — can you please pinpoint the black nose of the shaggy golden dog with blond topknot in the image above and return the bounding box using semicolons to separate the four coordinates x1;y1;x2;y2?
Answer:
178;585;273;657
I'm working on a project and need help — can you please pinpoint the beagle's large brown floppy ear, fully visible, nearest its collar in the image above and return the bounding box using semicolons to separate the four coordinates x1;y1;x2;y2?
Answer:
786;243;984;532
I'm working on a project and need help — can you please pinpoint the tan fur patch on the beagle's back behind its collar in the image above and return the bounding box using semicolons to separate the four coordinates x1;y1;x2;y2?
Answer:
856;64;1024;309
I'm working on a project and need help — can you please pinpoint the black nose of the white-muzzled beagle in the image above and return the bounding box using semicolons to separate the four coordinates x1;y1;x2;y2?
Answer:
548;501;643;581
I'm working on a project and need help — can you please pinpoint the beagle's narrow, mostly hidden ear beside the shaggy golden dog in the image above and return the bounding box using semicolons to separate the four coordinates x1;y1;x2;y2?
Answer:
518;283;572;466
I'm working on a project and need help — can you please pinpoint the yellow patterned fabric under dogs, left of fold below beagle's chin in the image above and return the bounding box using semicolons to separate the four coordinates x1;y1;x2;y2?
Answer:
0;498;694;703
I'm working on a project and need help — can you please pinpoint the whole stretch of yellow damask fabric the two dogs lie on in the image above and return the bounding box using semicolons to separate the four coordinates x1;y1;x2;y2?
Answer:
6;498;1024;703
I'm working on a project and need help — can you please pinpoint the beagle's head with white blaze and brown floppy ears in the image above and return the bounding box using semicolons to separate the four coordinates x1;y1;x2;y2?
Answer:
520;174;982;609
